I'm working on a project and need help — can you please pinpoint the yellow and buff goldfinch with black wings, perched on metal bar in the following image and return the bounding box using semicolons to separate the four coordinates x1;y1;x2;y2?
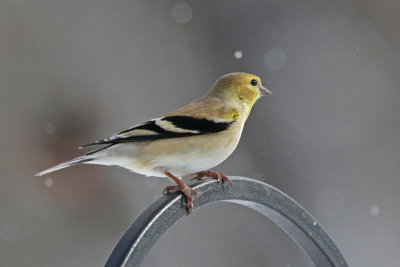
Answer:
36;72;271;215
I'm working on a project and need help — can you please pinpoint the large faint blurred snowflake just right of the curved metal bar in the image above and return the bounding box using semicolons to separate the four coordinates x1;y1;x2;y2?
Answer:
314;186;344;217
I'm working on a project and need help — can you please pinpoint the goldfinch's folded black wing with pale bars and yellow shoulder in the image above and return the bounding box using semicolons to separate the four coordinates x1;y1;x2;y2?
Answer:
82;100;237;150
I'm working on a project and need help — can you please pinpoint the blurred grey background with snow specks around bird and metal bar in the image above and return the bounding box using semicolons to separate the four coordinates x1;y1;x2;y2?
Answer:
0;0;400;267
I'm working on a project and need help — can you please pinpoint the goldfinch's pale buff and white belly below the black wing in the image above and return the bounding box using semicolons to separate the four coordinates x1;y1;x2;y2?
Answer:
119;133;240;177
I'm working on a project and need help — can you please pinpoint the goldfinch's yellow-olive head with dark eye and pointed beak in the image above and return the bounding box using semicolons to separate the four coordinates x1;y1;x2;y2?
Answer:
207;72;272;112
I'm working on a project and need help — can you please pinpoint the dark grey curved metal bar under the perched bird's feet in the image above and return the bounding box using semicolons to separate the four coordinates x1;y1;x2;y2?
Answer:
105;177;348;267
